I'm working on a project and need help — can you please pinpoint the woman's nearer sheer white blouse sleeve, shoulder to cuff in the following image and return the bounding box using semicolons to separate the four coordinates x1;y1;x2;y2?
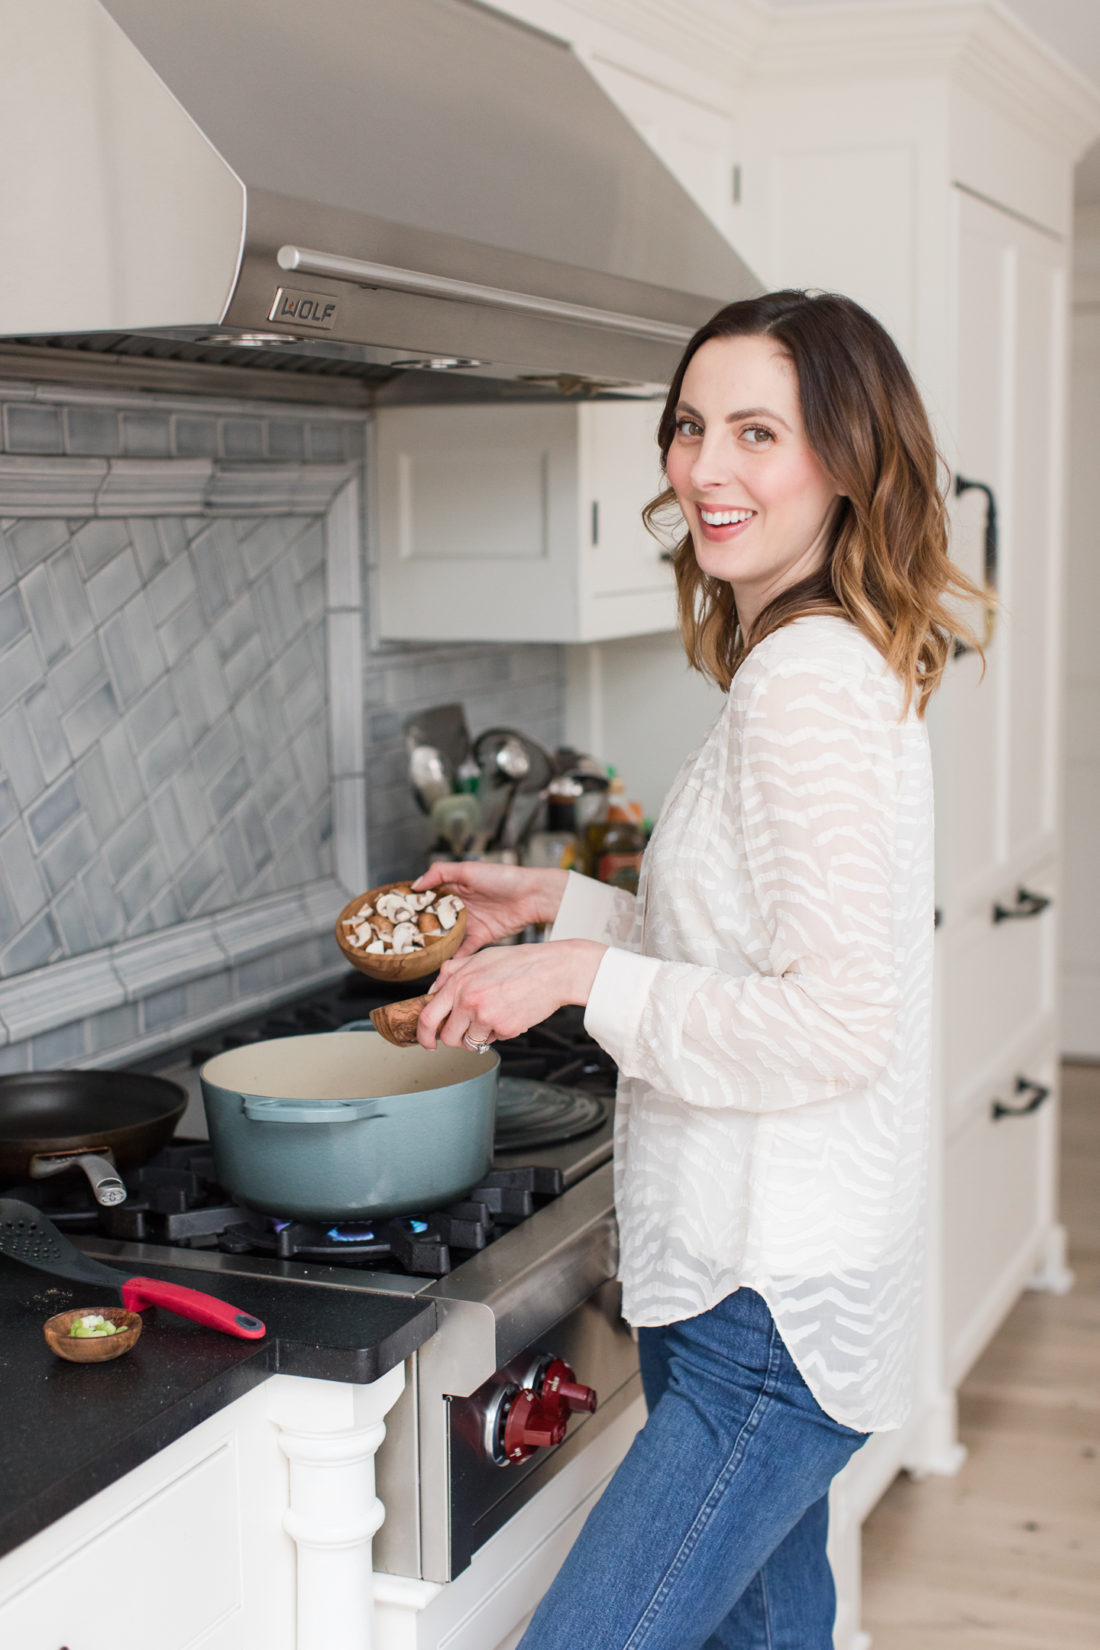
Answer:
585;663;900;1112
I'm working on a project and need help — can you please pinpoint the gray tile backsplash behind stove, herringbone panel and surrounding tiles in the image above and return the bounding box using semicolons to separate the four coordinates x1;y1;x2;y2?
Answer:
0;386;564;1071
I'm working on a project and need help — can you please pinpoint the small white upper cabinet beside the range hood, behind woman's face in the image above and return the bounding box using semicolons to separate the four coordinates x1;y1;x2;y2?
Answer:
376;401;675;642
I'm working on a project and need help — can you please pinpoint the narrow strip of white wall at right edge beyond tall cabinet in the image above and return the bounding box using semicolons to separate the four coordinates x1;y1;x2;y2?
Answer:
1062;206;1100;1059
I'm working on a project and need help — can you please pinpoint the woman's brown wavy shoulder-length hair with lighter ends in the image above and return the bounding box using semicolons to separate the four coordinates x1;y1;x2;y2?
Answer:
642;290;993;716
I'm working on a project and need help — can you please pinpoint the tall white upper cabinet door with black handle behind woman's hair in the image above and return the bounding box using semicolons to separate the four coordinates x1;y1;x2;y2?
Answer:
930;190;1065;904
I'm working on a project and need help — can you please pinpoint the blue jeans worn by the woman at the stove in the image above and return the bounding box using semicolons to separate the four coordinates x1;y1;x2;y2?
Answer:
519;1289;867;1650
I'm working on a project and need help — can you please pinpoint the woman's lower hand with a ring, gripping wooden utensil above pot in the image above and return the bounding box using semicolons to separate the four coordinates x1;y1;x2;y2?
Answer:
416;937;607;1048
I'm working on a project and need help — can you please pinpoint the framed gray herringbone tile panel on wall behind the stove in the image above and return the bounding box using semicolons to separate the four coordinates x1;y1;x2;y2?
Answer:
0;516;331;975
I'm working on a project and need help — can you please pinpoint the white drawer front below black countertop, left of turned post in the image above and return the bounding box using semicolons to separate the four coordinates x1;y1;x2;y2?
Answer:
0;1444;244;1650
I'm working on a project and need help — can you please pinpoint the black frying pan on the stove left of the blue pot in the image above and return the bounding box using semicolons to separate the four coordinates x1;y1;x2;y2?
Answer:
0;1071;186;1205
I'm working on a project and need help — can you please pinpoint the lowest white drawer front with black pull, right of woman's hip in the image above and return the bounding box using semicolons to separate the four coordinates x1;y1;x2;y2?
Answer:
943;1049;1057;1386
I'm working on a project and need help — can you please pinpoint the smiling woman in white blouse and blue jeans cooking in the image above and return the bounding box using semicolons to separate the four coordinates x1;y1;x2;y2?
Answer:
419;292;978;1650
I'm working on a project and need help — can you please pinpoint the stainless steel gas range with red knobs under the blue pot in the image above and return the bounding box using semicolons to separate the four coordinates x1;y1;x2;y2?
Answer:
23;975;640;1582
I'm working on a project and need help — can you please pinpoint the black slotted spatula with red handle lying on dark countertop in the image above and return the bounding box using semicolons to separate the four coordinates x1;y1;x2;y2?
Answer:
0;1198;267;1340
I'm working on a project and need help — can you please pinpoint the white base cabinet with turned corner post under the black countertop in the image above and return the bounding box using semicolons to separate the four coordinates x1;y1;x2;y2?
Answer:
0;1366;404;1650
